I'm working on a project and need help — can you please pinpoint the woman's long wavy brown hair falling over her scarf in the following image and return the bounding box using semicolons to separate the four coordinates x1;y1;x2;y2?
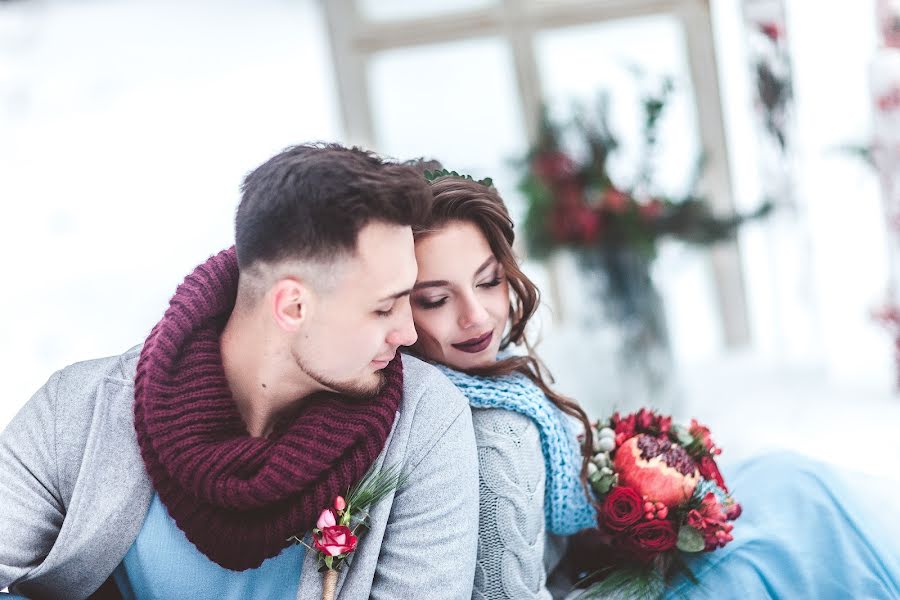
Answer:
413;175;593;498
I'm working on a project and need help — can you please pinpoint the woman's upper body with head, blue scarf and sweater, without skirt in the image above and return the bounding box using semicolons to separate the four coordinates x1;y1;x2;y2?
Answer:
410;177;596;599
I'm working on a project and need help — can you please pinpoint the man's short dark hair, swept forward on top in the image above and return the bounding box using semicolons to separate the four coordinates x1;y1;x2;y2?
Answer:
235;143;431;269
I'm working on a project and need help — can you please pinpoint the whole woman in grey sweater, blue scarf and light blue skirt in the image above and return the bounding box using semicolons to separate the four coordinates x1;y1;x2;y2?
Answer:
411;171;900;599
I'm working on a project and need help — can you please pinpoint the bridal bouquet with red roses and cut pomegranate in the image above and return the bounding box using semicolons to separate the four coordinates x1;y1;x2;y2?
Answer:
580;409;741;598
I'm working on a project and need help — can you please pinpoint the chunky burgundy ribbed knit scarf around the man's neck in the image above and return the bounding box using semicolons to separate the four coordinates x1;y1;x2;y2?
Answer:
134;248;403;571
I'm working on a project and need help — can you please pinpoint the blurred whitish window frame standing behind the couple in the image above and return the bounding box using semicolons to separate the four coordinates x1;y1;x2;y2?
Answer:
322;0;750;347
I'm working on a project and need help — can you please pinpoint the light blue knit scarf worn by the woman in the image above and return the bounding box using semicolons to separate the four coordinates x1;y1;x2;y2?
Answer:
435;365;597;535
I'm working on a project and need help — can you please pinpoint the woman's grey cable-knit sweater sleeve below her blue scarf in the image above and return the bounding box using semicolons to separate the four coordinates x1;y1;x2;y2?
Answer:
472;408;551;600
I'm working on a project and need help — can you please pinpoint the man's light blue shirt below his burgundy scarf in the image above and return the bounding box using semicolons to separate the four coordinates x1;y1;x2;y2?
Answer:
113;494;306;600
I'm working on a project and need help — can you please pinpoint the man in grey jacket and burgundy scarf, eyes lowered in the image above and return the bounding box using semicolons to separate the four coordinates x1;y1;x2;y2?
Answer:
0;145;478;599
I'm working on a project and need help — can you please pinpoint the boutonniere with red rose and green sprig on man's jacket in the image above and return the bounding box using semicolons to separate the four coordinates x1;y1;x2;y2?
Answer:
288;467;404;600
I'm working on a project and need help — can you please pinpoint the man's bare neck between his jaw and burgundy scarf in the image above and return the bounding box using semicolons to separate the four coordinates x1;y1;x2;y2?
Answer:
219;311;317;437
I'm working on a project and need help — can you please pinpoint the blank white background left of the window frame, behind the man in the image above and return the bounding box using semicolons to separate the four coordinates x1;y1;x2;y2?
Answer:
0;0;339;427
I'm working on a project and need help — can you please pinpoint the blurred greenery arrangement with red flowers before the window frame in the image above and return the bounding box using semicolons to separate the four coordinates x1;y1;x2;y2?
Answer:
519;77;772;397
